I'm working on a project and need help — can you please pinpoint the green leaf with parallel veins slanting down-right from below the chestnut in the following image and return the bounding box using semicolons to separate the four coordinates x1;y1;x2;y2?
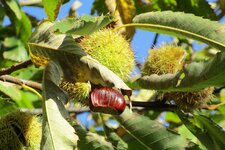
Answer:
116;110;187;150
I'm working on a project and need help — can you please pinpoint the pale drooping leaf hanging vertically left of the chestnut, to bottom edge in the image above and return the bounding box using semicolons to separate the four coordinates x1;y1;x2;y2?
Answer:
41;62;78;150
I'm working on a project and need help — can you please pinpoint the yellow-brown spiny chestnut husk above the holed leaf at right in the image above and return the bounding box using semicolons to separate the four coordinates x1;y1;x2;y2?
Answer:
141;45;185;76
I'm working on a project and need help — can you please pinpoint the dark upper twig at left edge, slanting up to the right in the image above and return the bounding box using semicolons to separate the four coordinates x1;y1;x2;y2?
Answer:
0;60;32;76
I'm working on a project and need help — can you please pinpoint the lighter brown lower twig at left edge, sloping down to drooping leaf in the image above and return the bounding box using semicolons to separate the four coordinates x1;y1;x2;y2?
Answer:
0;75;42;90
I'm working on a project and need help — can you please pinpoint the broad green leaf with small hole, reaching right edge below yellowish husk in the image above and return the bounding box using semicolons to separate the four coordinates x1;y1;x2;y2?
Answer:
130;53;225;91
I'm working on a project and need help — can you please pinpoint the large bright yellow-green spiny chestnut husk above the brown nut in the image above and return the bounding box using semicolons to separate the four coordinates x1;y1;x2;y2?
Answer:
80;29;134;80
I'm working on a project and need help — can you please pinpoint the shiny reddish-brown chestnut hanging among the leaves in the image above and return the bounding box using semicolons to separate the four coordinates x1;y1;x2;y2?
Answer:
90;87;126;115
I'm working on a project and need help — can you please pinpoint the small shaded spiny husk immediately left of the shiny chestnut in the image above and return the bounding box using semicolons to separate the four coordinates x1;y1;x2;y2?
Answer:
59;81;91;106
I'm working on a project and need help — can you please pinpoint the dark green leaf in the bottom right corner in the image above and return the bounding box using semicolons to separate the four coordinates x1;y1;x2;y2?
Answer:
177;112;225;150
